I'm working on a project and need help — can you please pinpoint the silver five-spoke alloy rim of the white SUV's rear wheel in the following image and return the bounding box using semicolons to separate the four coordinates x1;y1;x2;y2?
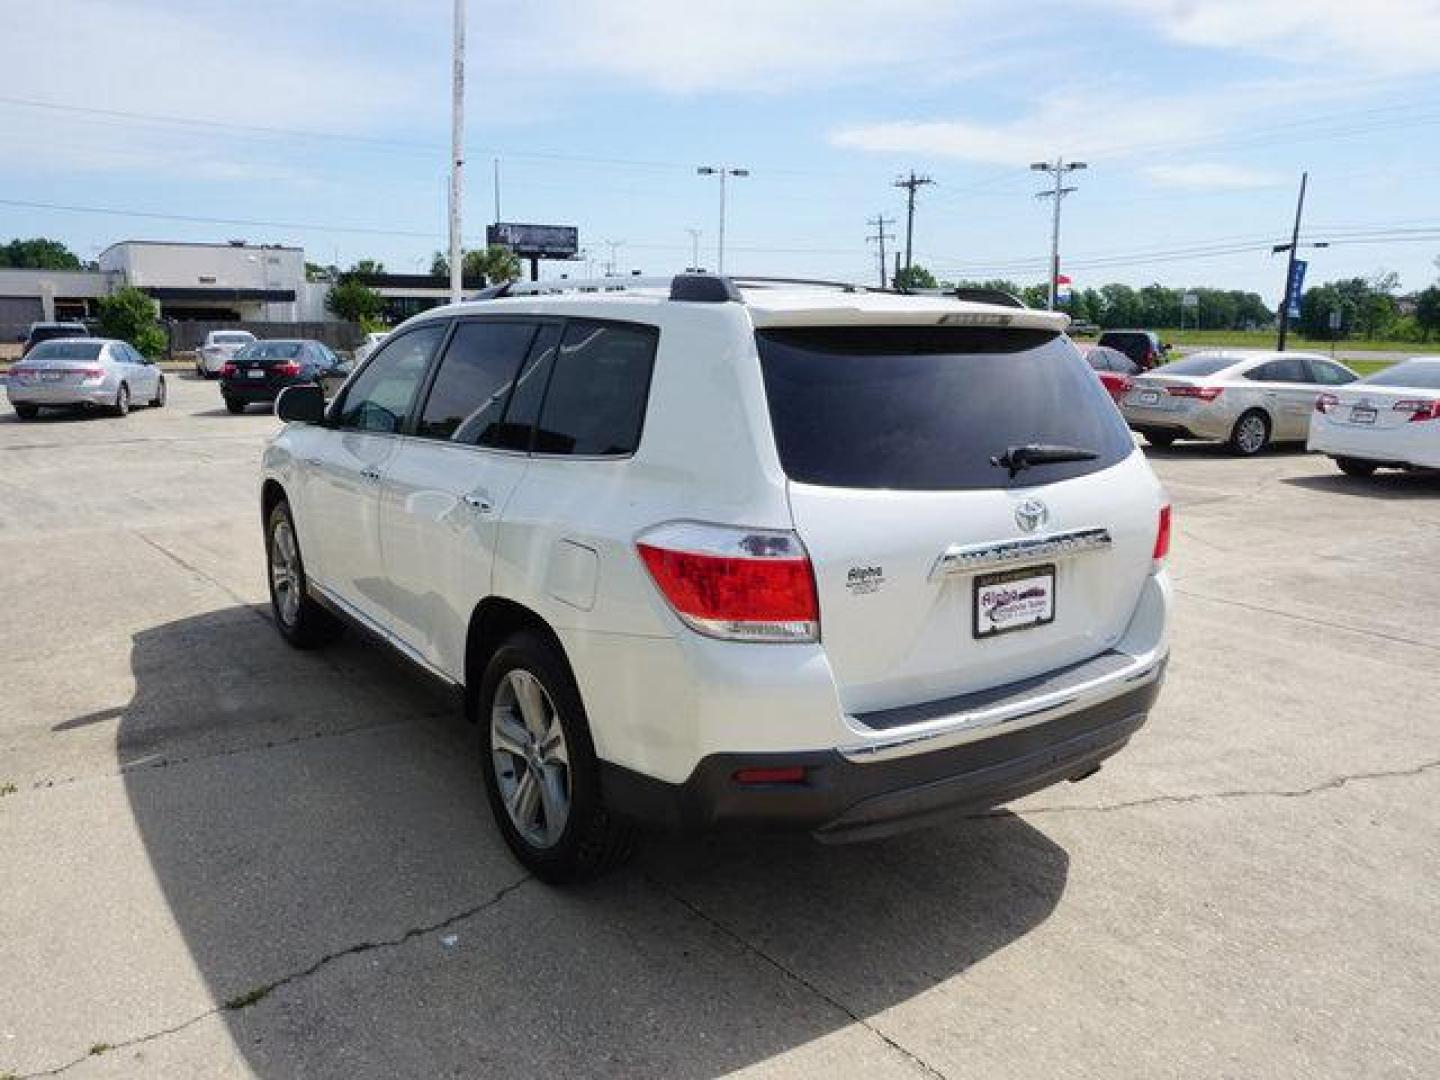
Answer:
490;668;572;848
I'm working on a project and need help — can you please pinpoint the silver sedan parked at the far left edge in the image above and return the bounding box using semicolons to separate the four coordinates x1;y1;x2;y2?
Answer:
6;337;166;420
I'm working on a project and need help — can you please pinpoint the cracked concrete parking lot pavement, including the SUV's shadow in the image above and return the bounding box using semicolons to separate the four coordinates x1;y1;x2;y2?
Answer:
0;377;1440;1077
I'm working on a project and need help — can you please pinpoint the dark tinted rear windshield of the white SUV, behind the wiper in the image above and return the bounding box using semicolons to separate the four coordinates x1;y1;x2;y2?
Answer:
756;327;1135;491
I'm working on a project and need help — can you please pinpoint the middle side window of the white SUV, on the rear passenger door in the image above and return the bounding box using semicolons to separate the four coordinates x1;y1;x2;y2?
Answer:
416;323;536;442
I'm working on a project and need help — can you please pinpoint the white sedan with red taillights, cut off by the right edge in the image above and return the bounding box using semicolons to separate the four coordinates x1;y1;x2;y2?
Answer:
1308;356;1440;477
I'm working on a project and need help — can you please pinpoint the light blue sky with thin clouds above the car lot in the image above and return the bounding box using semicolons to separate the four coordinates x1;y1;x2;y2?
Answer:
8;0;1440;302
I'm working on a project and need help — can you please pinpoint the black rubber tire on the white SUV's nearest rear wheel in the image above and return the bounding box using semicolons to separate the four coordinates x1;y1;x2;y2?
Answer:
475;631;636;884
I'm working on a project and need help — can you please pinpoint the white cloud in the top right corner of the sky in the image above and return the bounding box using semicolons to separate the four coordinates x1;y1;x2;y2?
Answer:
1086;0;1440;75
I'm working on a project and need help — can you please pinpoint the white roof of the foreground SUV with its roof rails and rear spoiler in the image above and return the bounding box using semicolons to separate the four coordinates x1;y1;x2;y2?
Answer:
406;274;1070;331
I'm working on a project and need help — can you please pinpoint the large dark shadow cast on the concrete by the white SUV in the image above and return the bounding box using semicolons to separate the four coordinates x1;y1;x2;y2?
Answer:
109;606;1068;1077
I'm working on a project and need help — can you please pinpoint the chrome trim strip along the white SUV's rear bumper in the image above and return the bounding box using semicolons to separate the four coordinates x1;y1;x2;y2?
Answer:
835;652;1164;763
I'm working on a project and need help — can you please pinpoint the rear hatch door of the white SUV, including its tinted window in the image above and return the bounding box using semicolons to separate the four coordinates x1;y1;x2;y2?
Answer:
757;325;1162;713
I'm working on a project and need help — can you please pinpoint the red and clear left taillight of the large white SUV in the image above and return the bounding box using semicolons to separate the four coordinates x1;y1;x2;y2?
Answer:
635;521;819;642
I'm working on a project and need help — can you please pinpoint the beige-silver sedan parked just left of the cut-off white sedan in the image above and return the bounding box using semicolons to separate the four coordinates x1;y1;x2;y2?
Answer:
1120;348;1359;456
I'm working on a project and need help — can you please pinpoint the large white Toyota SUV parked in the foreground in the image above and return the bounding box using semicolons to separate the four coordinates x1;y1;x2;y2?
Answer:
261;275;1169;881
